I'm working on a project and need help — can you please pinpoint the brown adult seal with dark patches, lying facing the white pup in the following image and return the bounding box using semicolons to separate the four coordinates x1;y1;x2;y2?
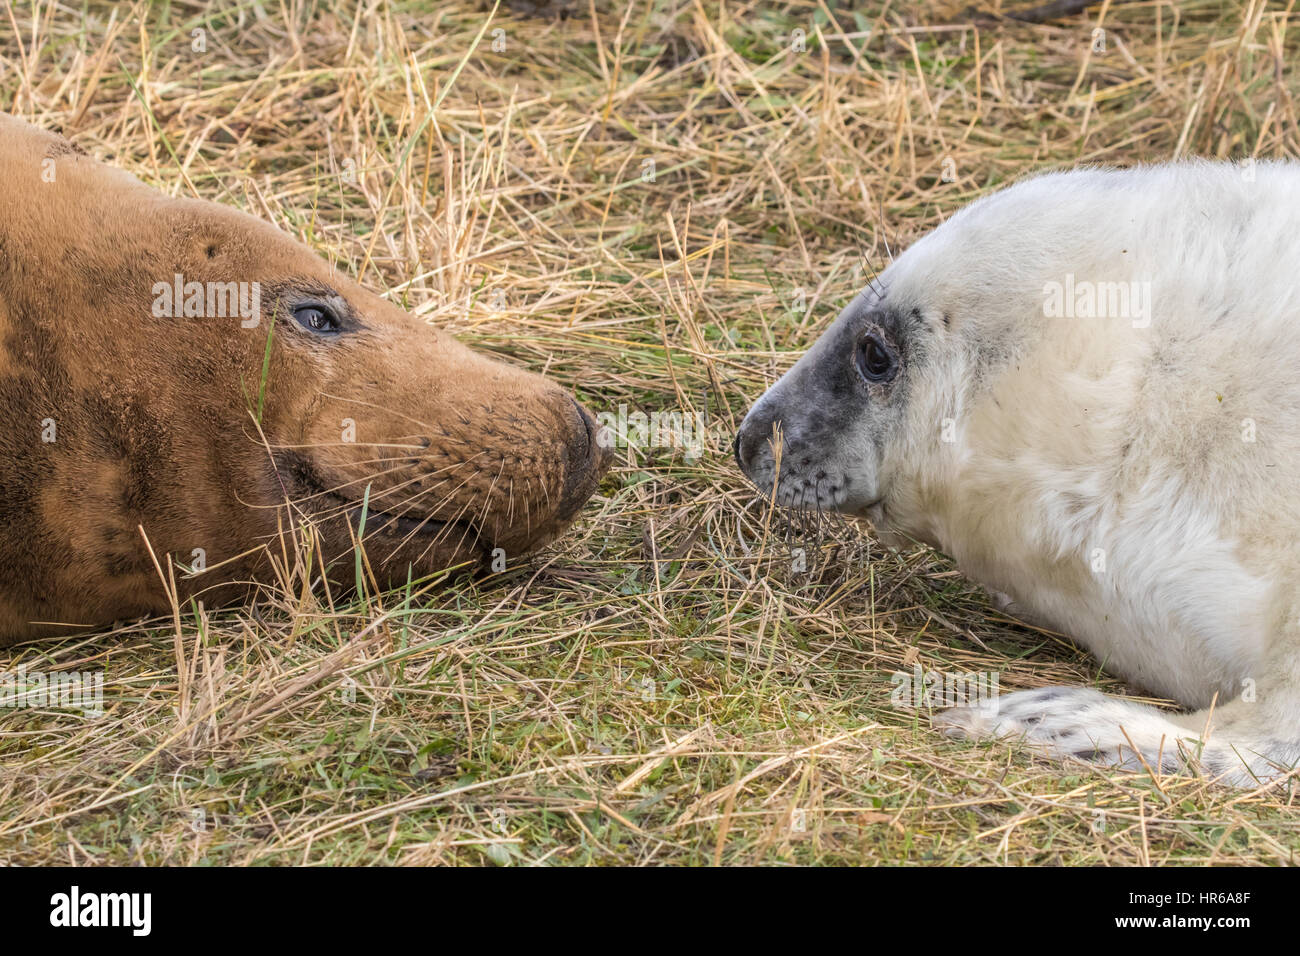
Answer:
0;116;608;644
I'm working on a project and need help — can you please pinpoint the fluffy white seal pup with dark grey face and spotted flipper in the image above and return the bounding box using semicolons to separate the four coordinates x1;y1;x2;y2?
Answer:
736;163;1300;786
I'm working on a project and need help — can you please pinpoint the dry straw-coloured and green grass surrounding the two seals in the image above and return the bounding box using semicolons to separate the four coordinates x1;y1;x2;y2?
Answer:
0;0;1300;864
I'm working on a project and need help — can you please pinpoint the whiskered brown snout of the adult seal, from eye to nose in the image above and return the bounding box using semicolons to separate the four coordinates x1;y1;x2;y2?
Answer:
264;293;608;581
